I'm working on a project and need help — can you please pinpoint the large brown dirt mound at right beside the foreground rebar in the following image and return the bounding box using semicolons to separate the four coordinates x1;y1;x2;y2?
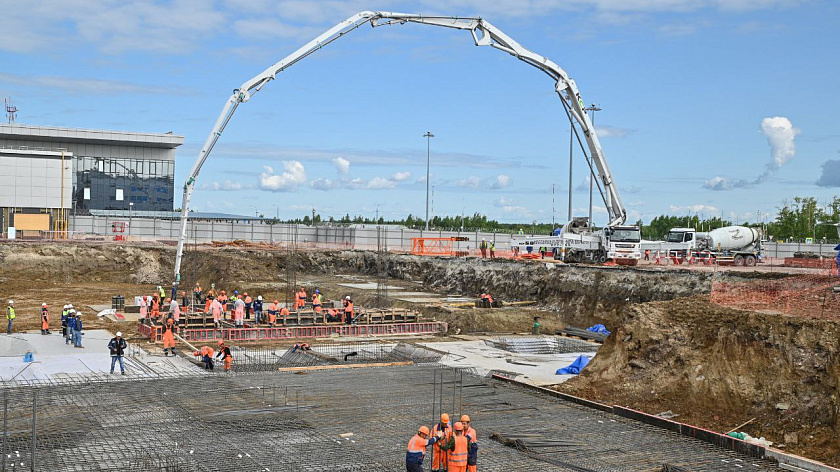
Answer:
557;298;840;465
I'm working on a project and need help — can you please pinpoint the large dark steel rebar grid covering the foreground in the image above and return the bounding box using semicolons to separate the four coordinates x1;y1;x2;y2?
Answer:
0;366;779;472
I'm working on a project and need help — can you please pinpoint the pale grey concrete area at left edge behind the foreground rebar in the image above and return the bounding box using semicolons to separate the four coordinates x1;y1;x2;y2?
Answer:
0;329;195;382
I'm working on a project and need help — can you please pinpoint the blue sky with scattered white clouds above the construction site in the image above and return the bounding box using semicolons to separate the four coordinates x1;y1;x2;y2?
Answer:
0;0;840;224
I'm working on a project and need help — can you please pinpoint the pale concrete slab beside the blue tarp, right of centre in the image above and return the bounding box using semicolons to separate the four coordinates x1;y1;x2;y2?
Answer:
422;339;595;386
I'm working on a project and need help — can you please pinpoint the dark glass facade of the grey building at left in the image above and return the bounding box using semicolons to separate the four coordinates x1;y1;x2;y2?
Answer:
73;156;175;211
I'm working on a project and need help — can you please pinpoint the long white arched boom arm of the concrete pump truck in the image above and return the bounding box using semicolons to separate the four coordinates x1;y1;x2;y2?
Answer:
173;11;627;288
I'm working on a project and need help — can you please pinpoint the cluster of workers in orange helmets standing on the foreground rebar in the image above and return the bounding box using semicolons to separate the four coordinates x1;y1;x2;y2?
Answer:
405;413;478;472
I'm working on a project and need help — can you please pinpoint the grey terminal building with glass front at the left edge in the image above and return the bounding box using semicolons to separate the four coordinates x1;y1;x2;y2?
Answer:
0;124;184;235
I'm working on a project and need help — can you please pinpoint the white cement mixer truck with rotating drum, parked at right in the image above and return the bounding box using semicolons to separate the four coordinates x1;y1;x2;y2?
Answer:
642;226;761;267
